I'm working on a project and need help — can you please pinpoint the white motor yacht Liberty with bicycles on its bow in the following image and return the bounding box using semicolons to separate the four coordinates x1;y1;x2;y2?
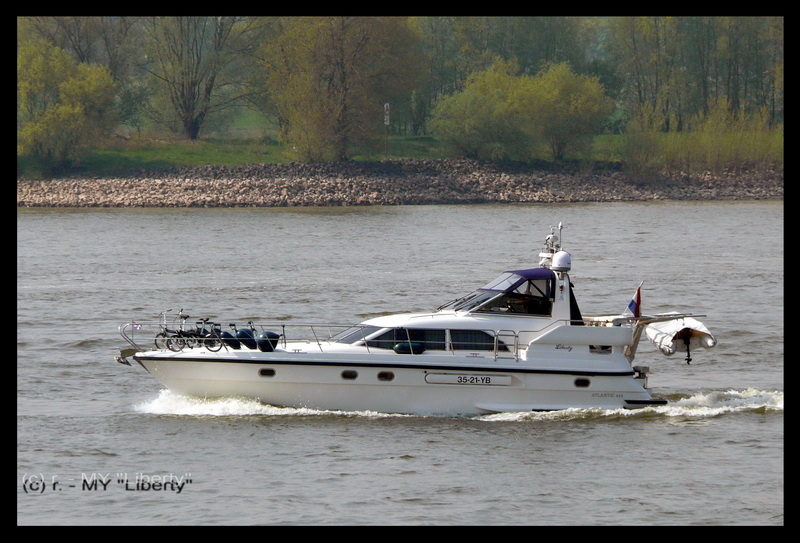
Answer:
116;224;716;415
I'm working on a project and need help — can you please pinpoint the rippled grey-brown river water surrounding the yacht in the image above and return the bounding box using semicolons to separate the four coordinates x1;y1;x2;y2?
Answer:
17;201;784;525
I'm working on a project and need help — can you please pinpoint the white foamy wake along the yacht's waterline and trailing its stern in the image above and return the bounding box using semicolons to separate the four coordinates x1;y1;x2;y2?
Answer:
134;389;783;422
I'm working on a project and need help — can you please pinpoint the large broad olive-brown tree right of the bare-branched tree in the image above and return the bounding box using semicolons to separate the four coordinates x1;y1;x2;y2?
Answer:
262;17;420;161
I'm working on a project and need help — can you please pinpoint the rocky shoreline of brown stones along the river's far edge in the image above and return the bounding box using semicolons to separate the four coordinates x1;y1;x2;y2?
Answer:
17;159;784;207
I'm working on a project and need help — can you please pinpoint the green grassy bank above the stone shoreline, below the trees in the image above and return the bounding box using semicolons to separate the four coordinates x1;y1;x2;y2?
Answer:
17;131;783;178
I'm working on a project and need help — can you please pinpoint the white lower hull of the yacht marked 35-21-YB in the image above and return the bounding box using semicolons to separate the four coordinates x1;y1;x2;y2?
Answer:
134;351;665;415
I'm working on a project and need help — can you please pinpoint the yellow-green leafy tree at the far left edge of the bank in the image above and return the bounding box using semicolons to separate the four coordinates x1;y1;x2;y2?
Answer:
17;21;114;166
